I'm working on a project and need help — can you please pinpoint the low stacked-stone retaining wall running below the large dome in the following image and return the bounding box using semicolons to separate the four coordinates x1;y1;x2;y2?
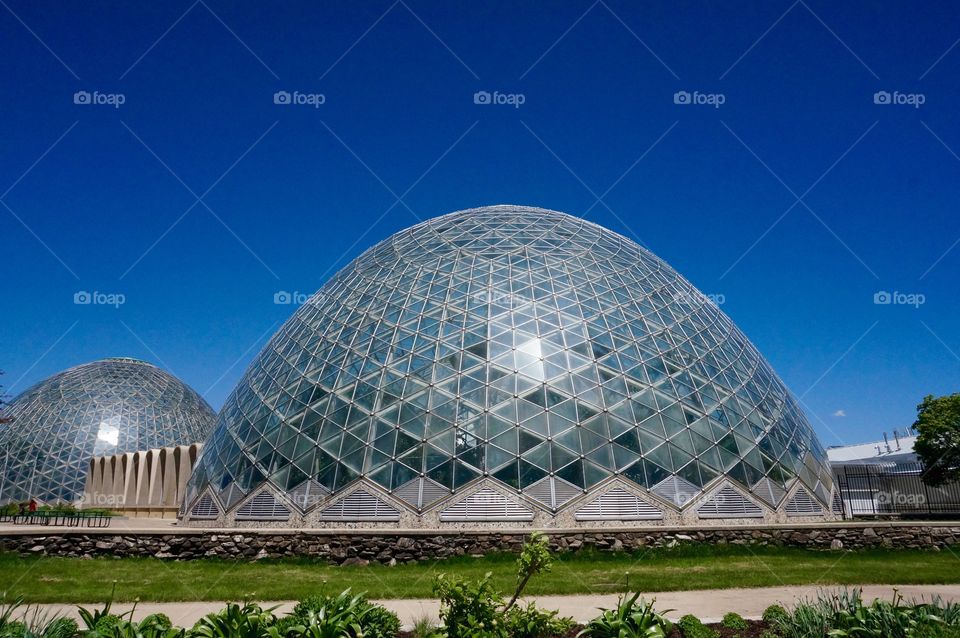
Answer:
0;523;960;565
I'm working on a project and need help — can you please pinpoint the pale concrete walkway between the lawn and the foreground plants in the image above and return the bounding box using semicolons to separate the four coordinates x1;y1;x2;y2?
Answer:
24;585;960;627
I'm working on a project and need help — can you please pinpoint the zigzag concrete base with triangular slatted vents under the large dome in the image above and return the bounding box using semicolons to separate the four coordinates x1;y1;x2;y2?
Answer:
182;477;840;531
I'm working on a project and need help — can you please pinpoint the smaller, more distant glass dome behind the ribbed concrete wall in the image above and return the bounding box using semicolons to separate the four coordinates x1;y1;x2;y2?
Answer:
0;358;216;503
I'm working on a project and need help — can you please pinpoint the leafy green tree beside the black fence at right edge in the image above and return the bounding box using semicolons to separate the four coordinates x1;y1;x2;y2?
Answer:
913;393;960;486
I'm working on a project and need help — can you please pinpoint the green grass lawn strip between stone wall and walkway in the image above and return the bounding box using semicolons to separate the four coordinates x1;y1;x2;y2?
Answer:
0;545;960;603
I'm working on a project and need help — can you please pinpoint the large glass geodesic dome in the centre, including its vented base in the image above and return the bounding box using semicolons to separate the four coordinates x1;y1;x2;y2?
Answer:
184;206;832;526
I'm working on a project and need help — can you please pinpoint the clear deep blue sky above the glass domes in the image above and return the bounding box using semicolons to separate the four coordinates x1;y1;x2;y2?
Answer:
0;0;960;445
